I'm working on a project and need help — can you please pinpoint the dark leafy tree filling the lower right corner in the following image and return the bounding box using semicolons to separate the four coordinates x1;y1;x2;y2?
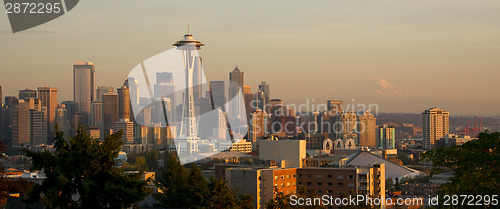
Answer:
423;132;500;207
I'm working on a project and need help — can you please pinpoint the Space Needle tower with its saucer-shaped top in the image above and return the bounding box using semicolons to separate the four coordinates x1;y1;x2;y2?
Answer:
173;29;204;154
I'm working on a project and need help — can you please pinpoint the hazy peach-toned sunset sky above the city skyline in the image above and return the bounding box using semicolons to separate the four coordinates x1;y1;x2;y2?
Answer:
0;0;500;115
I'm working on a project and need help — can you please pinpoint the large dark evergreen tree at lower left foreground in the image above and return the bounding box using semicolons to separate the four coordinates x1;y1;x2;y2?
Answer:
25;127;150;208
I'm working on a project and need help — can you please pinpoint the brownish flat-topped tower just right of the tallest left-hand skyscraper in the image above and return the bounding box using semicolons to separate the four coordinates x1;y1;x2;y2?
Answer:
102;93;119;133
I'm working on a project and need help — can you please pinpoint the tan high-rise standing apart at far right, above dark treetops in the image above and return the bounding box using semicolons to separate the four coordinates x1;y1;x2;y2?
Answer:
422;107;450;149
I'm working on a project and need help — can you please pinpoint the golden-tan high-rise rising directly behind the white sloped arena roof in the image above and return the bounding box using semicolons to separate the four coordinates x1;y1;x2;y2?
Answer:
357;110;377;147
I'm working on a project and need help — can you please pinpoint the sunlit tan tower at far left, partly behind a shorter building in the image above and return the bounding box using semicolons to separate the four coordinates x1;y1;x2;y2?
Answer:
38;86;57;143
